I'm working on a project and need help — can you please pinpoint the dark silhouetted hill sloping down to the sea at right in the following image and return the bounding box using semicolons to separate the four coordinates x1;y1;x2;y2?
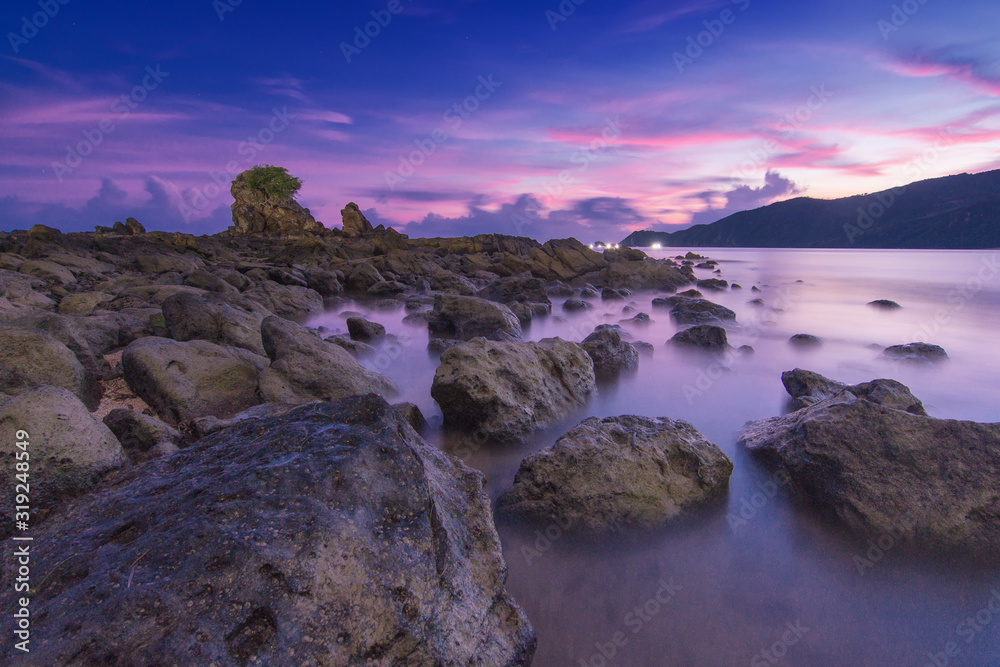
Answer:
621;169;1000;248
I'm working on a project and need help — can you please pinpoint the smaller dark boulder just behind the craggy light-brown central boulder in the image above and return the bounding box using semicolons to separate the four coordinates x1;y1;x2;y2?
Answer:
427;294;521;340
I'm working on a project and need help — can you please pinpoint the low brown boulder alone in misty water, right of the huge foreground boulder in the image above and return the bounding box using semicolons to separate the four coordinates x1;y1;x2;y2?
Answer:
497;415;733;533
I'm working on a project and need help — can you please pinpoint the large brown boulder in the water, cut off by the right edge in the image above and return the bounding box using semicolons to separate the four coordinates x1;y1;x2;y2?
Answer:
740;389;1000;554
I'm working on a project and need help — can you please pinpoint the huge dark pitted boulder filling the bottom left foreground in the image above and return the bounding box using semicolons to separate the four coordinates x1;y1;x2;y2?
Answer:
0;396;535;667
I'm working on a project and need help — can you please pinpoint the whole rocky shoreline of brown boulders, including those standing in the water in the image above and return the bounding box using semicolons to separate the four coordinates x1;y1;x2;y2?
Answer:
0;187;1000;665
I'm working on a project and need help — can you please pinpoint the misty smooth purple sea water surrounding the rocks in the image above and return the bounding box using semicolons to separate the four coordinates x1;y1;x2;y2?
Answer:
310;248;1000;667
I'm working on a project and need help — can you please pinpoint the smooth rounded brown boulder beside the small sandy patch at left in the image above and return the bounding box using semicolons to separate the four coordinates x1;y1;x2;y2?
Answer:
122;336;268;424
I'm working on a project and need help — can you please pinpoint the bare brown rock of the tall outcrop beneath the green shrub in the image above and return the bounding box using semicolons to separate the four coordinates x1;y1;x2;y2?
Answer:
229;170;325;236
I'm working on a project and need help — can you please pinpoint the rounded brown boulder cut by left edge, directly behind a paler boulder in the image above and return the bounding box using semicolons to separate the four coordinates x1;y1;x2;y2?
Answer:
0;325;94;408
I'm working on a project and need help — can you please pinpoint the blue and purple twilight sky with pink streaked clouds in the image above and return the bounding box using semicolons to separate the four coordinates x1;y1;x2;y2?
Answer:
0;0;1000;242
